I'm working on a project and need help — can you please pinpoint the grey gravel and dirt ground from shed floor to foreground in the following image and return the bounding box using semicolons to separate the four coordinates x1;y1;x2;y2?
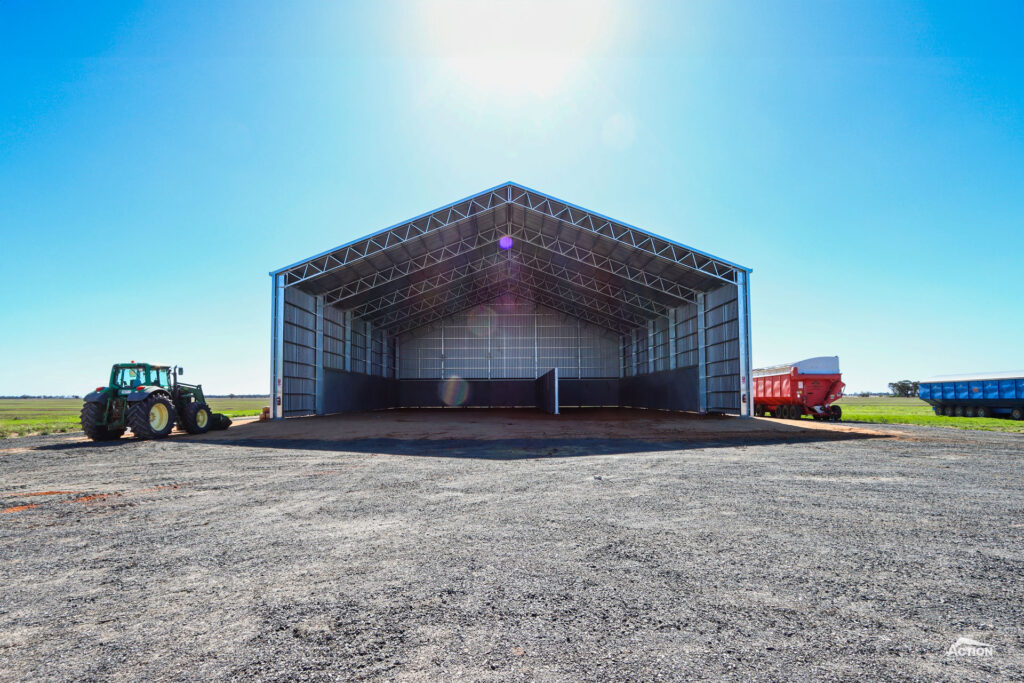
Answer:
0;411;1024;681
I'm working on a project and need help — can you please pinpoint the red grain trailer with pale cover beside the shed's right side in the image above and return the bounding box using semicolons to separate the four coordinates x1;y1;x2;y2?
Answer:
754;355;846;422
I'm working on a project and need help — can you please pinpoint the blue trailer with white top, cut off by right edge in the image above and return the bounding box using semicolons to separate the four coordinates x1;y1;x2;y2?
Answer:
918;371;1024;420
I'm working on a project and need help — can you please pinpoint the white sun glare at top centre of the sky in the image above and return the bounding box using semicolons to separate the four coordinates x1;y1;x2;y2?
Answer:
418;0;615;96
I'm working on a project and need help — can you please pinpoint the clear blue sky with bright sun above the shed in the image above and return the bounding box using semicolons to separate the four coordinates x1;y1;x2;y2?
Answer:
0;1;1024;394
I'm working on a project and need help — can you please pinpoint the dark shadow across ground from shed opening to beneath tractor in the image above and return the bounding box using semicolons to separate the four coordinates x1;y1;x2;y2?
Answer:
27;409;884;460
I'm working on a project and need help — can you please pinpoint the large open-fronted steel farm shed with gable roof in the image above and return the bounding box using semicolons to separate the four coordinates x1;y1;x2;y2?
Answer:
270;182;752;418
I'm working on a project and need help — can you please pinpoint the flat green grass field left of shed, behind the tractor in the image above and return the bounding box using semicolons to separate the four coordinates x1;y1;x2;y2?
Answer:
0;398;267;438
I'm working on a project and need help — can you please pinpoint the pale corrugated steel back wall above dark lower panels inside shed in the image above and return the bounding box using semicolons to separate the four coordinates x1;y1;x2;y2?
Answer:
398;295;620;379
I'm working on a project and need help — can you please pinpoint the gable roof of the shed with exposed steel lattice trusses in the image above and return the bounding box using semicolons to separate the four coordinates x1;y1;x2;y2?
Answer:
270;182;750;334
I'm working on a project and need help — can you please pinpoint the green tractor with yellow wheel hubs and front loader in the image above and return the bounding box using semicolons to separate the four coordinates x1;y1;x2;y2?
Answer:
82;360;231;441
